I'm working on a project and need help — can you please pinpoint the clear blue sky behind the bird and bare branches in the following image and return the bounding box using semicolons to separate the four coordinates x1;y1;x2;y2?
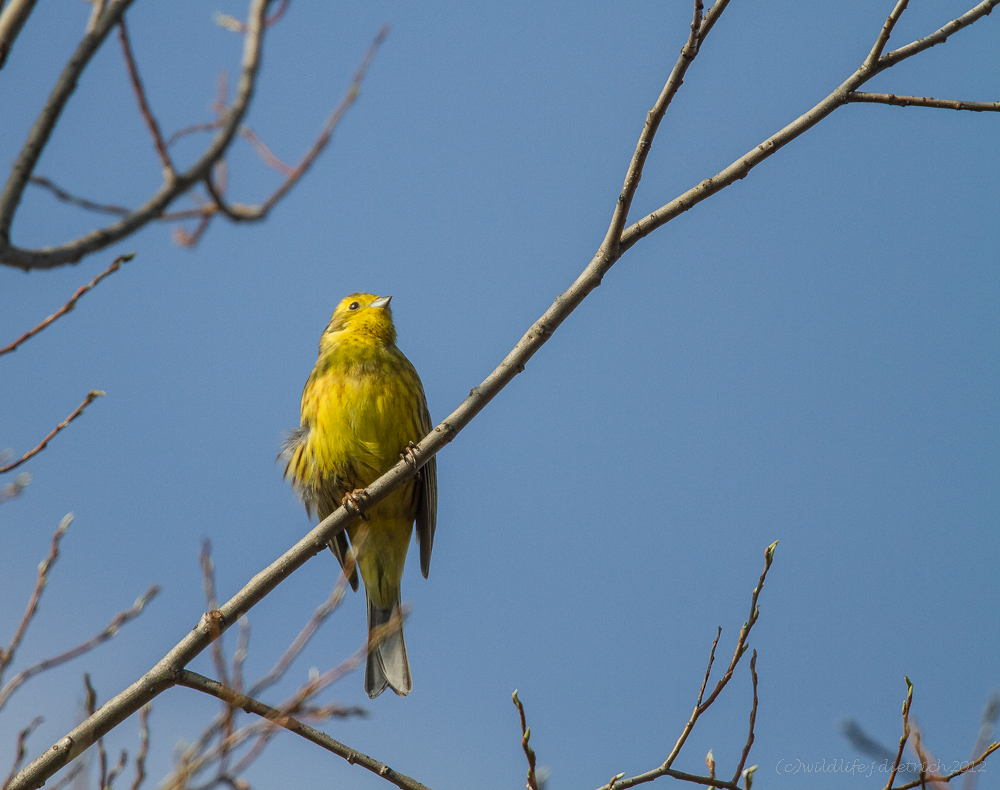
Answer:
0;0;1000;789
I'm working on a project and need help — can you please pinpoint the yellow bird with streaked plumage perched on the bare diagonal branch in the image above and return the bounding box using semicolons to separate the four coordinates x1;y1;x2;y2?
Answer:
280;293;437;699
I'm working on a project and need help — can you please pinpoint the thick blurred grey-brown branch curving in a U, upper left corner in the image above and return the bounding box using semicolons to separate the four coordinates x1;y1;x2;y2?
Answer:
0;0;268;271
